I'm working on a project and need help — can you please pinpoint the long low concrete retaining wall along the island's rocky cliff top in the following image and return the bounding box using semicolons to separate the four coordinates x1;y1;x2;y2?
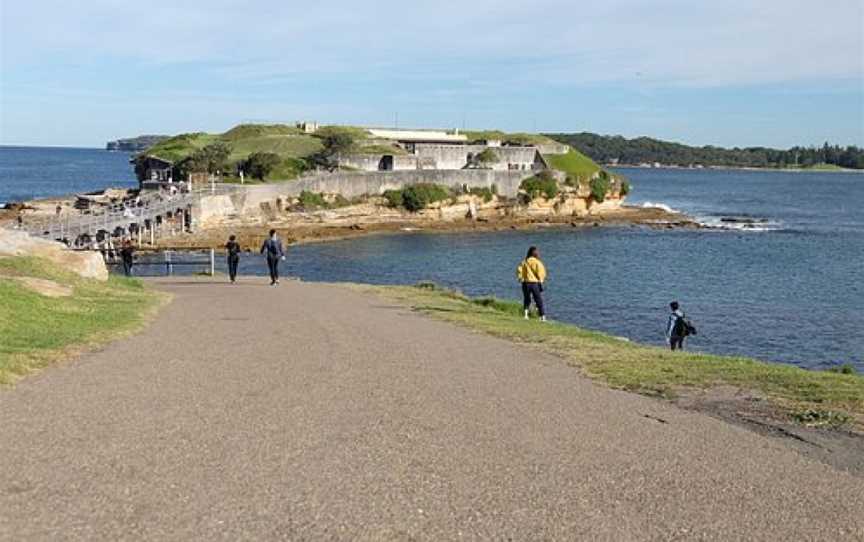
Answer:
233;169;534;214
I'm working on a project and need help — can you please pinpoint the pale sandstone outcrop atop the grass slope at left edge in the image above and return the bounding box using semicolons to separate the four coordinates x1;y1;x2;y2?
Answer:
0;228;108;281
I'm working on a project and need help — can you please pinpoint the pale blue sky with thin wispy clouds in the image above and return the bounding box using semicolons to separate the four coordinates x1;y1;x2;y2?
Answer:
0;0;864;148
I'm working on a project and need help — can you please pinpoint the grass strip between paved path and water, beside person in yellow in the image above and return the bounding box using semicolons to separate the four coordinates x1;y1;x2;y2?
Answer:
352;284;864;426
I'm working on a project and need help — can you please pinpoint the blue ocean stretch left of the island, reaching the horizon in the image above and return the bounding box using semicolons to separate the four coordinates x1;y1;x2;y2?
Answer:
0;146;138;205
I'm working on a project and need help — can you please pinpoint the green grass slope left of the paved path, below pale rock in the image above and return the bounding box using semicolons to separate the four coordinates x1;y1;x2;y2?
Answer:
0;257;164;384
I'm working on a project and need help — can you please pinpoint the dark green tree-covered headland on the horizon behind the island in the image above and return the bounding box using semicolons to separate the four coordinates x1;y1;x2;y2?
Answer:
545;132;864;169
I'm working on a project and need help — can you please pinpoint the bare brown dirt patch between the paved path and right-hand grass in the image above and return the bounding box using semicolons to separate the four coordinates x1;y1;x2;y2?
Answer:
673;386;864;477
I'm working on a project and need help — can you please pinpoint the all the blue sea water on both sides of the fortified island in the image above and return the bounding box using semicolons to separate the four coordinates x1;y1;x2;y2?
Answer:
0;147;864;371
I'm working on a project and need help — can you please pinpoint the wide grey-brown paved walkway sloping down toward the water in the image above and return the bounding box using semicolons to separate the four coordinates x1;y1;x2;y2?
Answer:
0;279;864;541
